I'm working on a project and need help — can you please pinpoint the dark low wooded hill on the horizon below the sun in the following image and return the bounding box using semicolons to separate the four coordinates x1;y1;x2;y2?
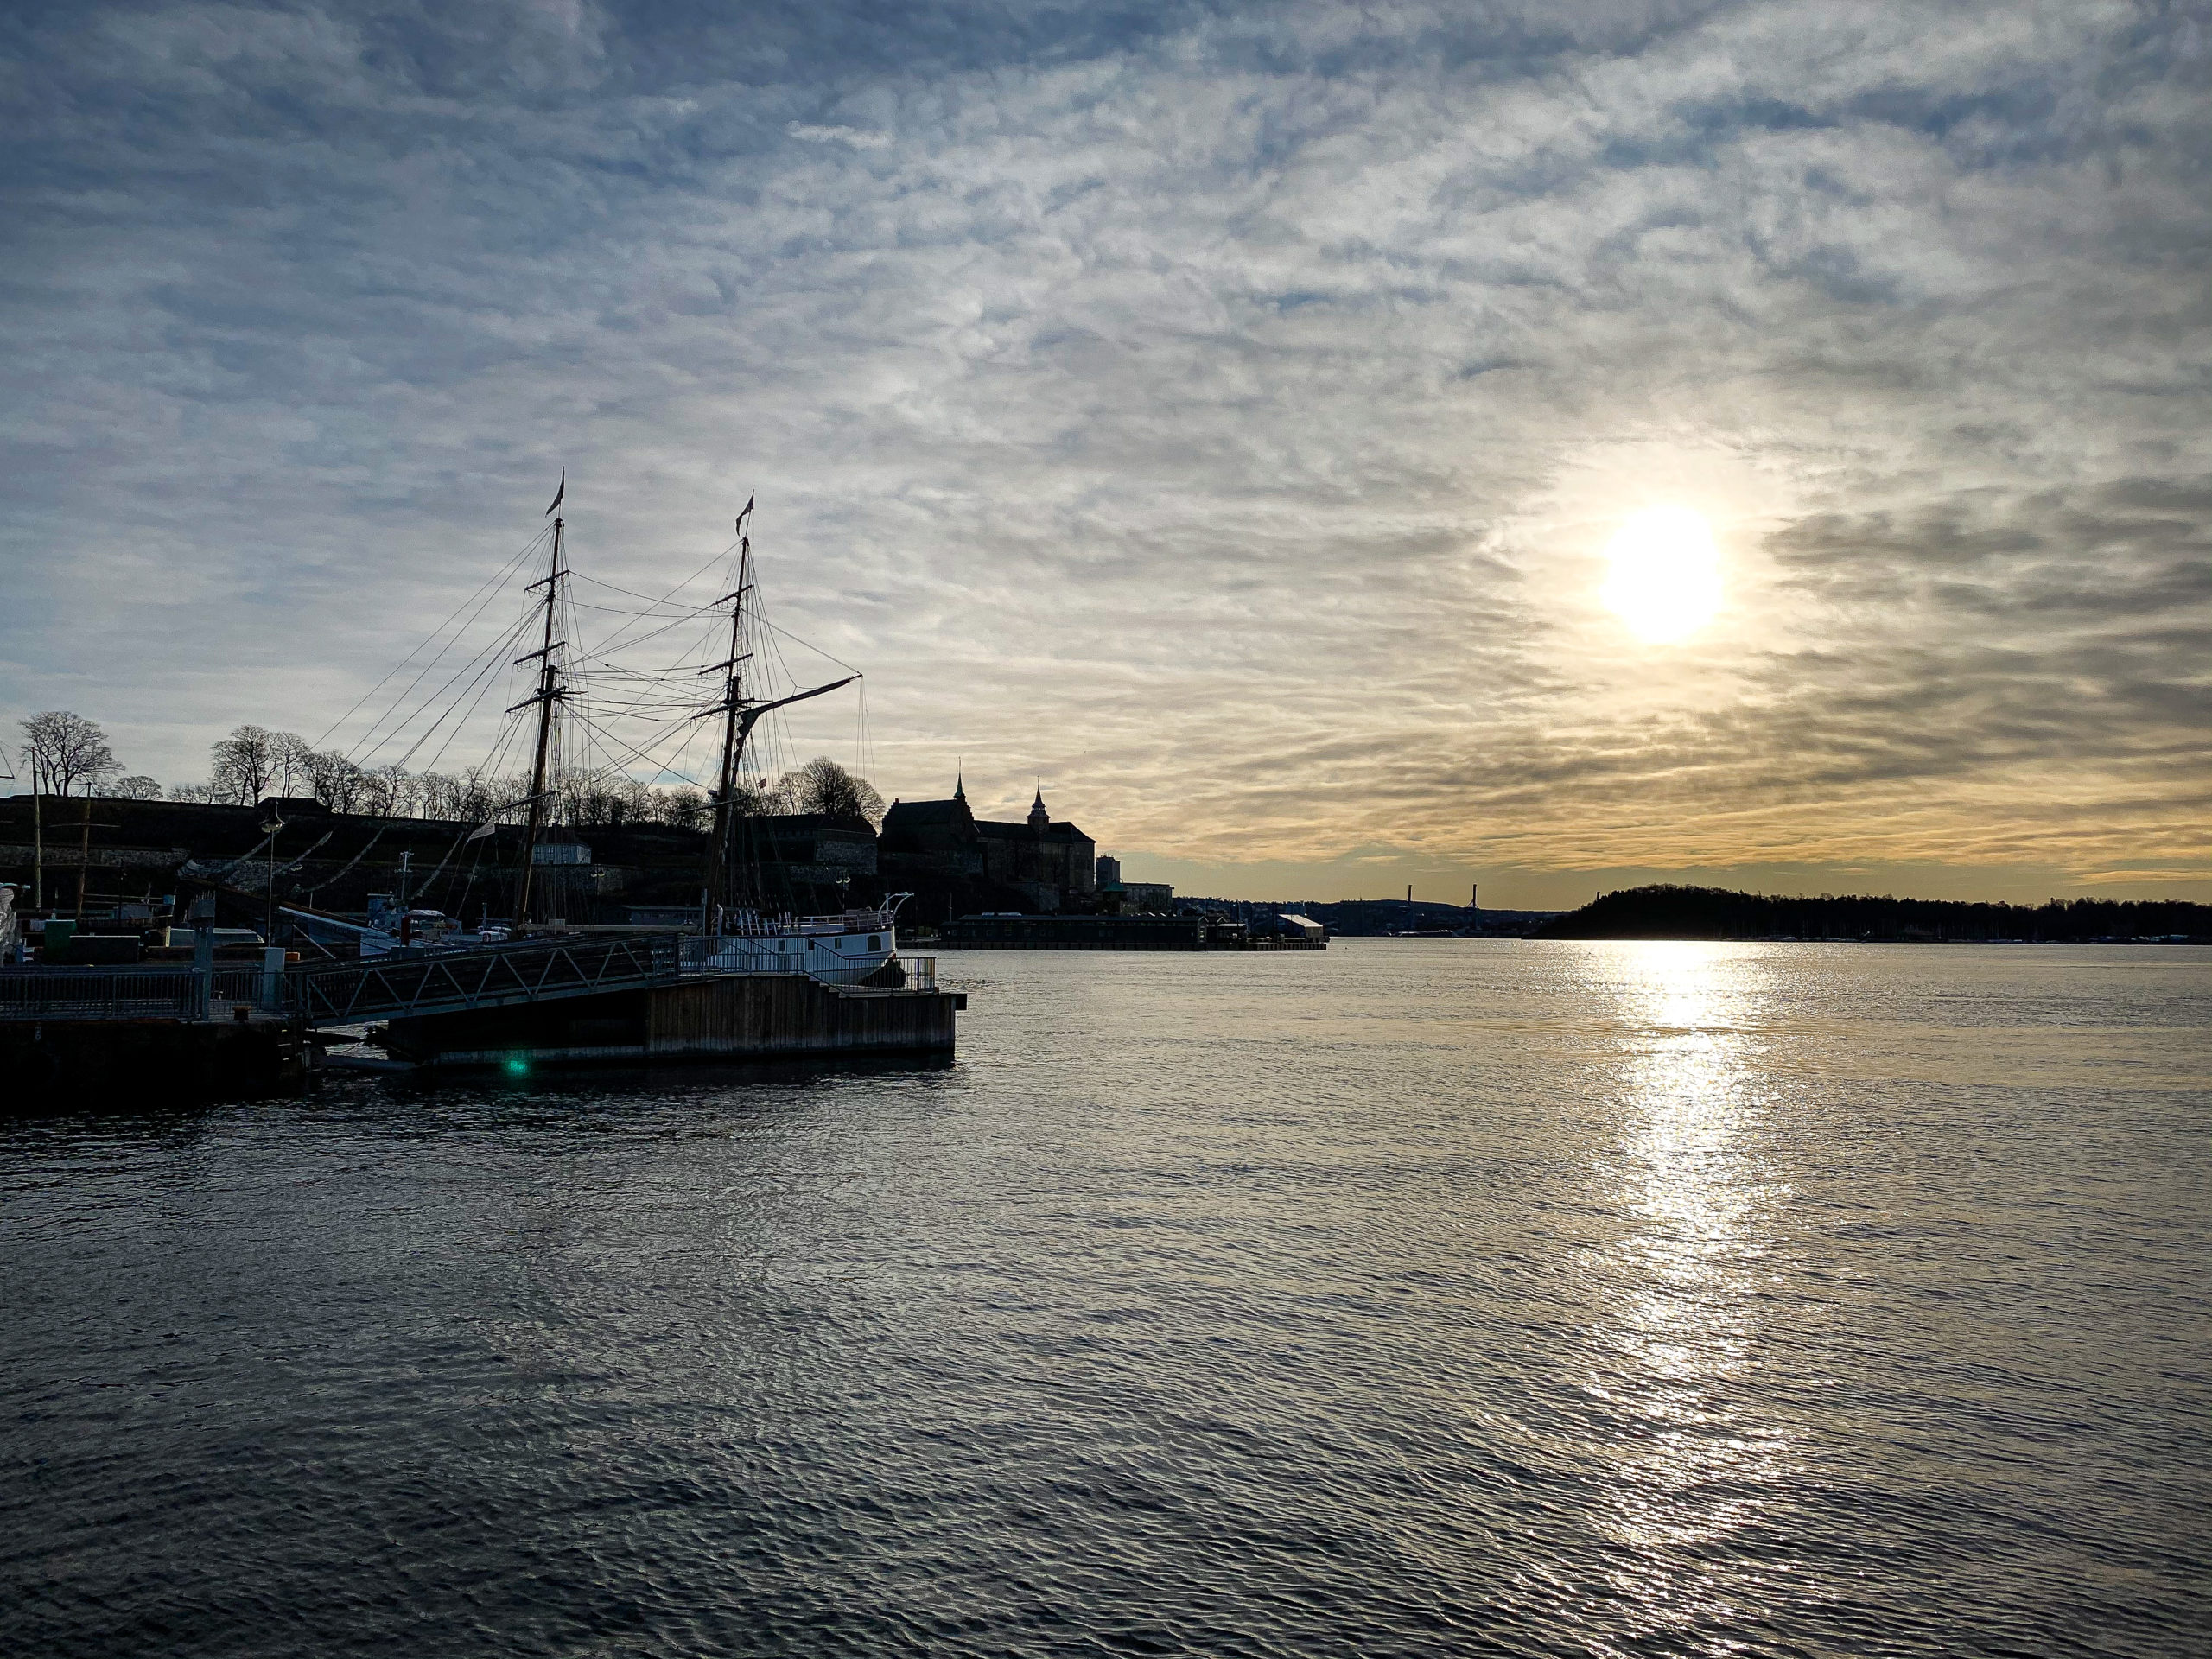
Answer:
1531;885;2212;943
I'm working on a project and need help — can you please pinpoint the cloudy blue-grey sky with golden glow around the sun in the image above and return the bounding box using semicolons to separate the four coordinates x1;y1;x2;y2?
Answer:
0;0;2212;905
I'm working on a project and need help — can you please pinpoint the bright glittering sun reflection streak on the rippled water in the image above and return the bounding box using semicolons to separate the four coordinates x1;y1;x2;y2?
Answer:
1588;944;1792;1619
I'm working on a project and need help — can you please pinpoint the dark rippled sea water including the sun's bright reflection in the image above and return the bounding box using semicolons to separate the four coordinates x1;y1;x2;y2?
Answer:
0;940;2212;1656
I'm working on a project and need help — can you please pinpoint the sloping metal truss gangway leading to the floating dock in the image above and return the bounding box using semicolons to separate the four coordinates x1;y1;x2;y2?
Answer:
285;933;681;1027
